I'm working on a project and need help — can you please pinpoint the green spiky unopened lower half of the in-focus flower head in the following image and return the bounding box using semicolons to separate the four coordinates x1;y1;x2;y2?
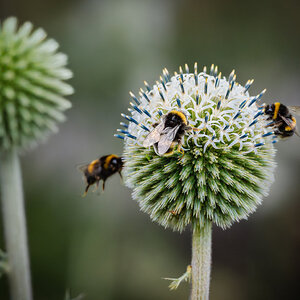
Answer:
124;146;274;231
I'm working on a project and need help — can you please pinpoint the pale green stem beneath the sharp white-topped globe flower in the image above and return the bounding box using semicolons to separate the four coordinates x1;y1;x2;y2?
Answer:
191;223;212;300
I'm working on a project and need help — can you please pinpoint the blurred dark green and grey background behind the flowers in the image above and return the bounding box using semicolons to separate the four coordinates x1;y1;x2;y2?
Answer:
0;0;300;300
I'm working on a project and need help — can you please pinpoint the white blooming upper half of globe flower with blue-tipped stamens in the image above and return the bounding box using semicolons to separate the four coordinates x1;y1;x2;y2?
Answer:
117;64;276;157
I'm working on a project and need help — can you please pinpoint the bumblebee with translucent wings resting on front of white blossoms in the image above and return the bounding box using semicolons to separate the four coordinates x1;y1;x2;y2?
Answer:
143;110;198;156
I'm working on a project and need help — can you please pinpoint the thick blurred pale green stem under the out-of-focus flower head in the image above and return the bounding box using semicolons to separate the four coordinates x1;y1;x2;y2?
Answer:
0;150;32;300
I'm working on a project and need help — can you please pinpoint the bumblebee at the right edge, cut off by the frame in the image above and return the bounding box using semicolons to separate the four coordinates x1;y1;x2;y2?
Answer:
264;102;300;138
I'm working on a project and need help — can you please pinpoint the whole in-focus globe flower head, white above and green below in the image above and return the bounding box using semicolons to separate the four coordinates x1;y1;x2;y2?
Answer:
116;64;277;231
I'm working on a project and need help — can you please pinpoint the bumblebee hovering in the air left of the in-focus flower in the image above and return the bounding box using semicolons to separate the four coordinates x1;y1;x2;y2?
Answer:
79;154;123;196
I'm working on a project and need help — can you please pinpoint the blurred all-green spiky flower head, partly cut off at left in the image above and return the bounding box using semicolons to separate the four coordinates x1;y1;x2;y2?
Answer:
0;17;73;150
